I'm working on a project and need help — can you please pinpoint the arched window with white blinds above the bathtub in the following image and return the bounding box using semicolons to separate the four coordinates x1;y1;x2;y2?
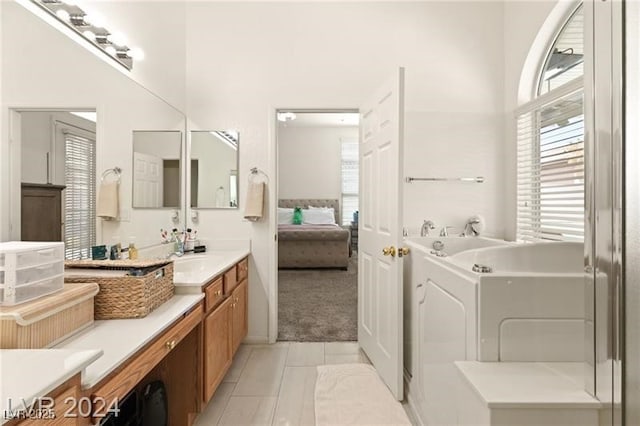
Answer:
517;5;584;241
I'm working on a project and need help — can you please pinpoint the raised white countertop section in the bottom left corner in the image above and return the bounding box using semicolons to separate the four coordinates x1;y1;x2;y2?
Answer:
0;349;102;423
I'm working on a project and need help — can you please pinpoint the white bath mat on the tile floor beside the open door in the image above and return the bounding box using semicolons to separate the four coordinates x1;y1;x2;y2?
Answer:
315;364;411;426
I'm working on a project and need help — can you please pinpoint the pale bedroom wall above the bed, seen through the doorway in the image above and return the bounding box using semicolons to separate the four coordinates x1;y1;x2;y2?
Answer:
277;124;358;200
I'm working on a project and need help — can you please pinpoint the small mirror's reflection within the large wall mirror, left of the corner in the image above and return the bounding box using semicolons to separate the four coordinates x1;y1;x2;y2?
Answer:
132;130;182;209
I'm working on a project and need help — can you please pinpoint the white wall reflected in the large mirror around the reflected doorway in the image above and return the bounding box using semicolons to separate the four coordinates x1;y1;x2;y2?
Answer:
0;2;185;246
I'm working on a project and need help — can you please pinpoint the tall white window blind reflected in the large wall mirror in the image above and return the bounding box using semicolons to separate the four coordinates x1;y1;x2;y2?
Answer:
64;130;96;259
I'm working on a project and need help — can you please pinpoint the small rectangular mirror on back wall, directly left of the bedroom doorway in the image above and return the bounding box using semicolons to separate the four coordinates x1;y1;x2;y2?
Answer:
189;130;240;209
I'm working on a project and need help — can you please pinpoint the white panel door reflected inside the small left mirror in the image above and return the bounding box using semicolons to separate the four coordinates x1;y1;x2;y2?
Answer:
133;152;163;207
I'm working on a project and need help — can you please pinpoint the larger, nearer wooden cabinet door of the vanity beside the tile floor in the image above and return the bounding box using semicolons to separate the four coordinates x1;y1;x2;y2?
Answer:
204;298;233;403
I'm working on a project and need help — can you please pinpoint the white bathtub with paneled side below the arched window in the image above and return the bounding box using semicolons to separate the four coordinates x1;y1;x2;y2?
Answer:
409;243;585;425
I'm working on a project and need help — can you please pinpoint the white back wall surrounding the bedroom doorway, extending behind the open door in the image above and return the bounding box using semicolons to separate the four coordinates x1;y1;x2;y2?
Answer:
186;2;504;339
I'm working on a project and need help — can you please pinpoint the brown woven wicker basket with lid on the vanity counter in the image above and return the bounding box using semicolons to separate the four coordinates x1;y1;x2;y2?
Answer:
64;260;174;320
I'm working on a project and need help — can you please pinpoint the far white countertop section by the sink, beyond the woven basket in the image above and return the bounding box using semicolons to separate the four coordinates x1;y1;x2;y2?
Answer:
173;248;250;294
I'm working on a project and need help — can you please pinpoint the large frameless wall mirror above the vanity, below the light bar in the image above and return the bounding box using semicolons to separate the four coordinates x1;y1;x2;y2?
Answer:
0;2;186;250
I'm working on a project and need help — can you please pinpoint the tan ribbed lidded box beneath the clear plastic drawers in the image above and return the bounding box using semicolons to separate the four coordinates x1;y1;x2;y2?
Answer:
0;283;99;349
